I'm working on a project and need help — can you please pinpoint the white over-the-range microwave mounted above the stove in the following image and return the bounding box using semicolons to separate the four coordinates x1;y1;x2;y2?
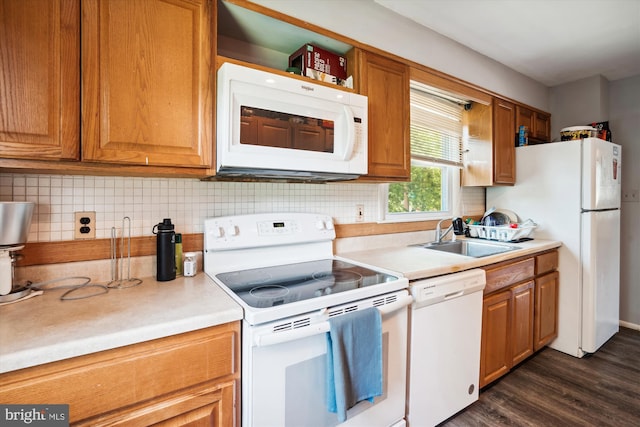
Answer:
216;62;368;181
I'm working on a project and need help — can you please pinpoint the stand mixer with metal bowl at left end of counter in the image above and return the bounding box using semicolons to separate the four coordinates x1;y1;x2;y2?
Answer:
0;202;35;298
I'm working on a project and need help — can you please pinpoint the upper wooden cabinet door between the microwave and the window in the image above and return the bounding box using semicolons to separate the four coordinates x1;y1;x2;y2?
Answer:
360;52;411;181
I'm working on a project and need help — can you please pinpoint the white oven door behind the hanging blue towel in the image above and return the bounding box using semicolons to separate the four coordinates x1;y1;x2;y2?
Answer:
242;290;412;427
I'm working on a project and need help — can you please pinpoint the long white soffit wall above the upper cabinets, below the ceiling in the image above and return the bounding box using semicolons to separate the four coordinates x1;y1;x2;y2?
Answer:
251;0;549;111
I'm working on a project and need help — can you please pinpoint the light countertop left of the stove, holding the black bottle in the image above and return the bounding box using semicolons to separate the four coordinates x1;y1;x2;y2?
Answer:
0;272;243;373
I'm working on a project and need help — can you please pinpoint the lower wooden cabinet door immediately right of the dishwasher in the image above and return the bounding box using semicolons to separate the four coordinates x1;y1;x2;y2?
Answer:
480;290;512;387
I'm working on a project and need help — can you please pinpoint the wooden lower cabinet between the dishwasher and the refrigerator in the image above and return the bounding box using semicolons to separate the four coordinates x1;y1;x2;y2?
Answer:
480;251;559;387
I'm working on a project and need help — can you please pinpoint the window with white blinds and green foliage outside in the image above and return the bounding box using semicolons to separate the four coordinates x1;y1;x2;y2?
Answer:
381;81;467;221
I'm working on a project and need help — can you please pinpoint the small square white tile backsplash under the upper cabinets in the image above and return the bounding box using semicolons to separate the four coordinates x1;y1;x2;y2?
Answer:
0;174;484;242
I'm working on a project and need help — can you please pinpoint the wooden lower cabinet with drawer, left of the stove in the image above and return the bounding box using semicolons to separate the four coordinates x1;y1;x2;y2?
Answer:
0;322;240;426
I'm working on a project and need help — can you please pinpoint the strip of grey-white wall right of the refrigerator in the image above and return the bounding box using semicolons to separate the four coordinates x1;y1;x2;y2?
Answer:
609;75;640;328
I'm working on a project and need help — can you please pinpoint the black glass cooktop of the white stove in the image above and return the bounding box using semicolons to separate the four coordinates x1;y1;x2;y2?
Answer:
216;259;397;308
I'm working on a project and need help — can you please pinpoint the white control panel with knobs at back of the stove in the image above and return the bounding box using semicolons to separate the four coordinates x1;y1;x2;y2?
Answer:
204;212;336;251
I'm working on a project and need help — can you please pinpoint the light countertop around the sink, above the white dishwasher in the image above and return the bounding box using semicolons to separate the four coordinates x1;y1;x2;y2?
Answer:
337;239;562;281
